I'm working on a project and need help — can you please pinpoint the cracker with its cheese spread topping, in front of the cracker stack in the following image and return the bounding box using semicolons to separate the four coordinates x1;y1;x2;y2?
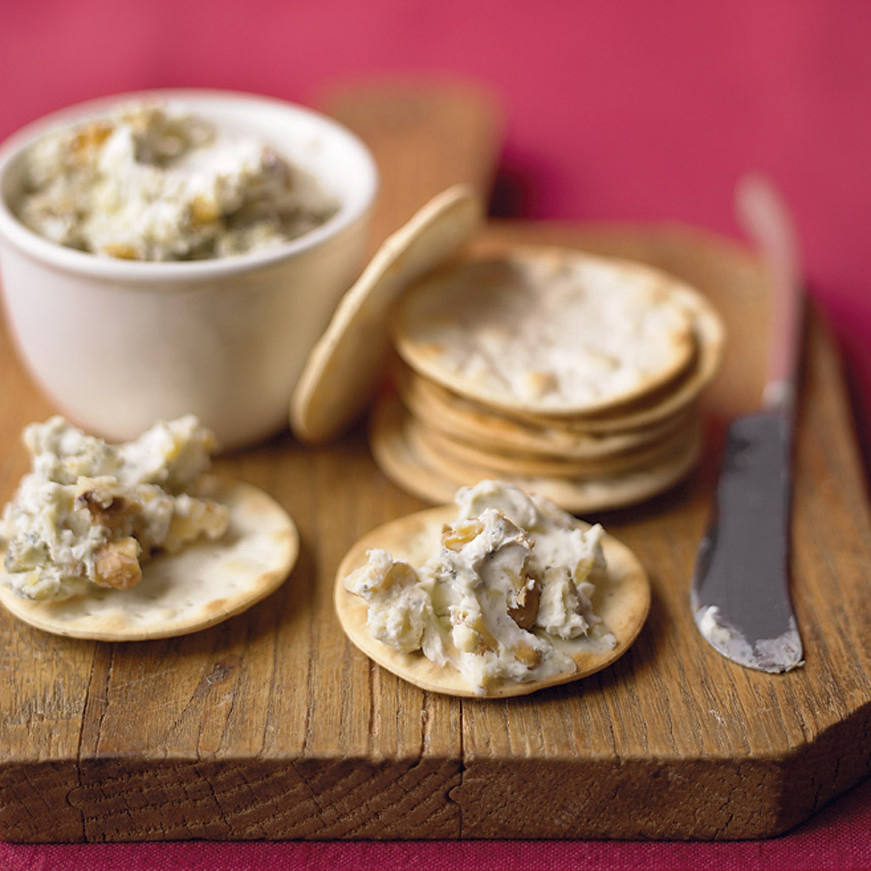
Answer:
335;481;650;696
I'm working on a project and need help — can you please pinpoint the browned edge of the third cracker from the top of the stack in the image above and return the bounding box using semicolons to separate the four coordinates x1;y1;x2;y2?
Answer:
394;365;696;461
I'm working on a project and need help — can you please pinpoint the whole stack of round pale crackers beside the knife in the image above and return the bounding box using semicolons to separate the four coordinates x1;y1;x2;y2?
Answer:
371;248;723;513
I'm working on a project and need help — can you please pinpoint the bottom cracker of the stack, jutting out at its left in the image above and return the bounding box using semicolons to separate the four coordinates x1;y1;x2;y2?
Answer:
369;399;701;514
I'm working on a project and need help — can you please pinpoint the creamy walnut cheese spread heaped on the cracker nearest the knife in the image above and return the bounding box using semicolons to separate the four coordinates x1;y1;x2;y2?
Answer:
345;481;616;695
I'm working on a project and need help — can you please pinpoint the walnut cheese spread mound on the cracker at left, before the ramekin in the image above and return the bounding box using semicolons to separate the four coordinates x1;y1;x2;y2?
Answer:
0;415;229;600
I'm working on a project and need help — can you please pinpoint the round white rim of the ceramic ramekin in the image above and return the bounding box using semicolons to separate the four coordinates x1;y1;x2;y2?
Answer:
0;88;379;283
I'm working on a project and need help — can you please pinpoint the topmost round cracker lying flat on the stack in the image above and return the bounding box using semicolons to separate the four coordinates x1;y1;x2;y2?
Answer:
392;248;696;416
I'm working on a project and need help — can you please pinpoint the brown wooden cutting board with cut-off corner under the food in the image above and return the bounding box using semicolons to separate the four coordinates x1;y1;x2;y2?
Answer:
0;86;871;842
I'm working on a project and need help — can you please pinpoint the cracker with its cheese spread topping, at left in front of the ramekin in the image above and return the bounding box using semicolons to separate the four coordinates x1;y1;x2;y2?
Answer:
0;415;298;640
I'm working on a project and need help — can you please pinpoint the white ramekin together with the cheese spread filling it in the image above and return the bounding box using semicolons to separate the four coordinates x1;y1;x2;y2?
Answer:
0;90;378;449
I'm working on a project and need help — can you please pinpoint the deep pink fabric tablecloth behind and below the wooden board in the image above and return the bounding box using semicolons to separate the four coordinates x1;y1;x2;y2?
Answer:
0;0;871;871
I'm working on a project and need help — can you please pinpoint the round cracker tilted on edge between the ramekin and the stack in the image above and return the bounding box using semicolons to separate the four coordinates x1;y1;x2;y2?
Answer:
290;184;483;444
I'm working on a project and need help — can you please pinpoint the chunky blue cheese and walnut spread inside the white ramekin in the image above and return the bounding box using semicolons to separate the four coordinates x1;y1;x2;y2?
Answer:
16;102;337;261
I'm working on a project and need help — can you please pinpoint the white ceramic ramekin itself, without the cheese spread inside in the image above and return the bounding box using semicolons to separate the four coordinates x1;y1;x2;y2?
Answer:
0;90;378;449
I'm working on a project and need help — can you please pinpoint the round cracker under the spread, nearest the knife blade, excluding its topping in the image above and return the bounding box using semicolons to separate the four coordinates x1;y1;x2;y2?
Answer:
334;505;650;698
